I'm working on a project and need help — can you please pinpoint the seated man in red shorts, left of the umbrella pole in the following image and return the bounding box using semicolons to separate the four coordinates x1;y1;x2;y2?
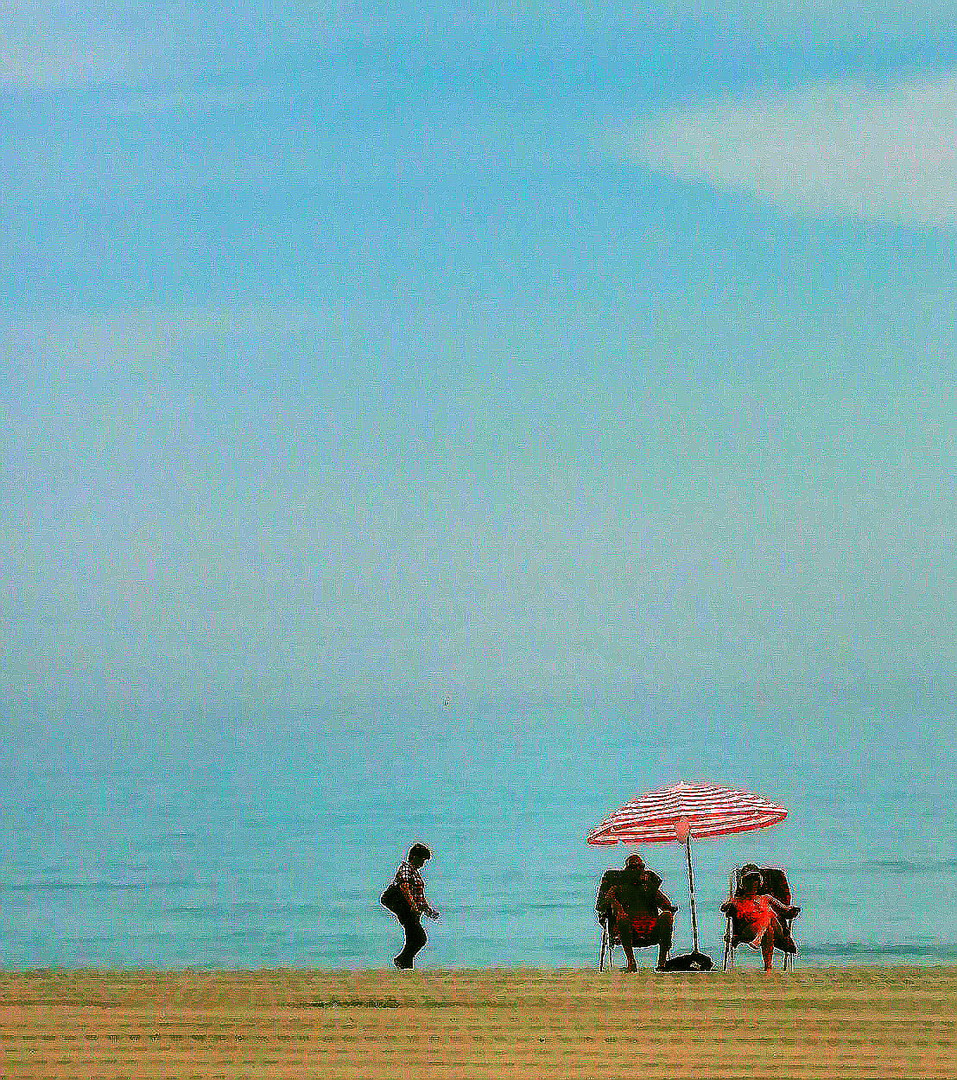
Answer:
597;855;677;971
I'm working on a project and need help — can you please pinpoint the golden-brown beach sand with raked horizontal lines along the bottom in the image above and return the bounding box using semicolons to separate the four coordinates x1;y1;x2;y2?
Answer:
0;967;957;1080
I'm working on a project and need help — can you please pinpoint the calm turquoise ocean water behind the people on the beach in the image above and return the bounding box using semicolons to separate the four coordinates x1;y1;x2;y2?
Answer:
0;710;957;970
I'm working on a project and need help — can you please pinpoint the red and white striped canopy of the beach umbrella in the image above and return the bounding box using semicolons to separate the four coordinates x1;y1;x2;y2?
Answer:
587;781;787;845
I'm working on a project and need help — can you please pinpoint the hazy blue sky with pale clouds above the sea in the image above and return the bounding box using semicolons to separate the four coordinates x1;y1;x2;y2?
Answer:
0;0;957;752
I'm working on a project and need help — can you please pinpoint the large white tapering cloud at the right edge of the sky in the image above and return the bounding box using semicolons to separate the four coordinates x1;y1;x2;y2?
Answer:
626;73;957;227
